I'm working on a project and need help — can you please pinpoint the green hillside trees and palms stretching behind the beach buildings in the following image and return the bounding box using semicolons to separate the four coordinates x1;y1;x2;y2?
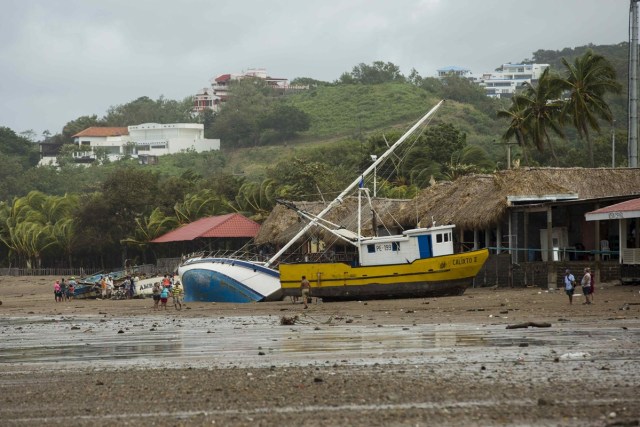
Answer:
0;44;626;268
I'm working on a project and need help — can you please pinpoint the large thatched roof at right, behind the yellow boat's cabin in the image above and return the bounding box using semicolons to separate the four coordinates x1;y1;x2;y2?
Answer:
396;168;640;229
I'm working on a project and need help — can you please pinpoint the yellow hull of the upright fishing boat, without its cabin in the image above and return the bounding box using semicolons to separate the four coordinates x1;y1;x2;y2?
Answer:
280;249;489;301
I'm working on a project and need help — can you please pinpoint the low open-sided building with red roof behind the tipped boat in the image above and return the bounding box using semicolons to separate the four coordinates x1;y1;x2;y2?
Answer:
151;213;260;251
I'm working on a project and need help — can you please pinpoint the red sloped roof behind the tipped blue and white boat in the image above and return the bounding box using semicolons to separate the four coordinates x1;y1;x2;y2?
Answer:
151;213;260;243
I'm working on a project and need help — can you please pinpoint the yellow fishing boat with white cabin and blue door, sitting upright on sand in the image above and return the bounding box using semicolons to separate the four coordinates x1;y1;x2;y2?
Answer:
279;225;489;301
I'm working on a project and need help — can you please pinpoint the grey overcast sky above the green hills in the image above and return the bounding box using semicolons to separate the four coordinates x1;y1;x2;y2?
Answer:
0;0;629;134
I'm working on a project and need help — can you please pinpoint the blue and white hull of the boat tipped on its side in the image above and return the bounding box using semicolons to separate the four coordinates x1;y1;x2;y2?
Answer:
178;258;282;303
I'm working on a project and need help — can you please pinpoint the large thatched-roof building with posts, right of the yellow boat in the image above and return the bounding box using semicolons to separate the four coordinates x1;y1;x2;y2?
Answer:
396;168;640;262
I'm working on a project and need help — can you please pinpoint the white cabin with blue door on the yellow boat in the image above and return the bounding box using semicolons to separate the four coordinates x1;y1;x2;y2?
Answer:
359;225;455;266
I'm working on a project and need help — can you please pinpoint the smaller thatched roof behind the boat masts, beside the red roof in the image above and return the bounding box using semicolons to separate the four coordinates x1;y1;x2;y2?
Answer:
255;197;408;245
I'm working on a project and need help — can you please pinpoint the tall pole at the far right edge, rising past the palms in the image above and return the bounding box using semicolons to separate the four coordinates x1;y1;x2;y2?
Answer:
628;0;640;168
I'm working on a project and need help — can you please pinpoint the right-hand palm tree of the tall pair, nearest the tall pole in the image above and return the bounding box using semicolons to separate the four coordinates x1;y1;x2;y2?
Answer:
558;49;621;167
